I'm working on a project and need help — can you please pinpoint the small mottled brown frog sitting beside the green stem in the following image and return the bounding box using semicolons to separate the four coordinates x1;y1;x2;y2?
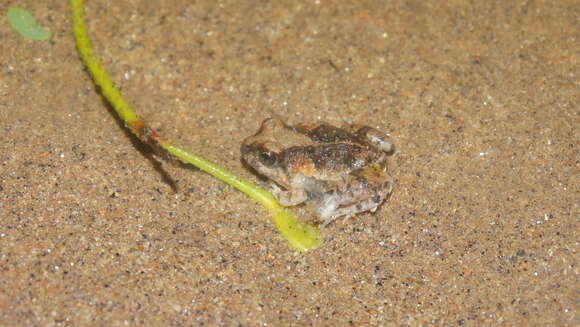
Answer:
242;118;394;225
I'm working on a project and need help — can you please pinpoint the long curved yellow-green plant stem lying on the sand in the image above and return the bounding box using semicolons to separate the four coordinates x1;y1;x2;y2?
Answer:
70;0;321;252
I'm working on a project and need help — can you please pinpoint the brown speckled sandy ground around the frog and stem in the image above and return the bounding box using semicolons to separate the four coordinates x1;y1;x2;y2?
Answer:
0;0;580;326
